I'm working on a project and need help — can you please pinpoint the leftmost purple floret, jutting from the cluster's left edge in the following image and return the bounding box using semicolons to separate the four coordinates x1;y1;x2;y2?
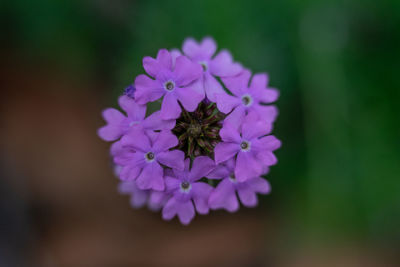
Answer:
98;95;175;141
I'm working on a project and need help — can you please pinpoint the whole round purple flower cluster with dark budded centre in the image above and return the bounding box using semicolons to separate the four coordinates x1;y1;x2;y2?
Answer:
98;37;281;224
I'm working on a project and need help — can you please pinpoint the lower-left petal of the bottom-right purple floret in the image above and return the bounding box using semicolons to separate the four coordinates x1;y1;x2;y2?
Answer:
208;179;239;212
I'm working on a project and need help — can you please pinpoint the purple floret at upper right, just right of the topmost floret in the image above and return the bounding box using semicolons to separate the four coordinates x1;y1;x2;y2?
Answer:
216;70;279;126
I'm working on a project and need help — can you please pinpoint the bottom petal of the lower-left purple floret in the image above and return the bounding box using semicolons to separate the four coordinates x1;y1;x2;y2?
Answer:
136;162;165;191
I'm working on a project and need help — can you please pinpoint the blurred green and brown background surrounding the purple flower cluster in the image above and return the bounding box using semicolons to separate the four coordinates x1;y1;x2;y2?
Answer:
0;0;400;267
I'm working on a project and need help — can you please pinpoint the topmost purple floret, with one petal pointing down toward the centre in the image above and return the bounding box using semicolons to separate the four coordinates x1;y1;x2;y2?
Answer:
182;37;242;102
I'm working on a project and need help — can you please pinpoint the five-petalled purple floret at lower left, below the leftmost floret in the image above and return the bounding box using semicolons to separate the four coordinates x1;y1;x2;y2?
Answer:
114;128;185;191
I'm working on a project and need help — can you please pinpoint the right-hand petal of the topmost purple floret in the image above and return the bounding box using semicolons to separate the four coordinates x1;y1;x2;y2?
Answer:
210;50;243;77
